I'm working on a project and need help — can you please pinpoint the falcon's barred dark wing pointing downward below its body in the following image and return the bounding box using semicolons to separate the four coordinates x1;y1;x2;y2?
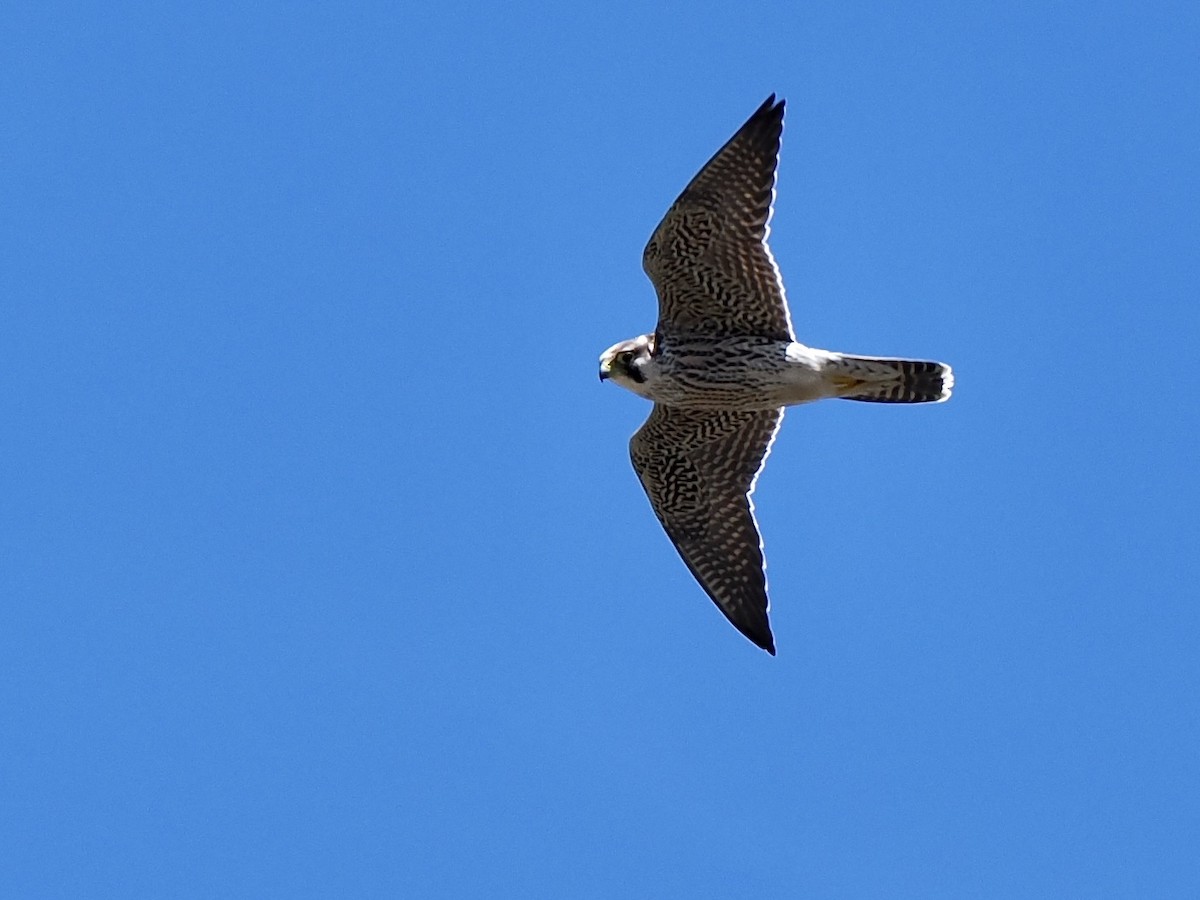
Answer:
629;404;784;655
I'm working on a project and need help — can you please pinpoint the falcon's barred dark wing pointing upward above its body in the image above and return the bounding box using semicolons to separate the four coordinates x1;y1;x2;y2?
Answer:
642;94;794;341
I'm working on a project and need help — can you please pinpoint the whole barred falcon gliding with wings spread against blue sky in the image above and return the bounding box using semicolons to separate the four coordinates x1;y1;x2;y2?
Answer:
600;94;954;655
